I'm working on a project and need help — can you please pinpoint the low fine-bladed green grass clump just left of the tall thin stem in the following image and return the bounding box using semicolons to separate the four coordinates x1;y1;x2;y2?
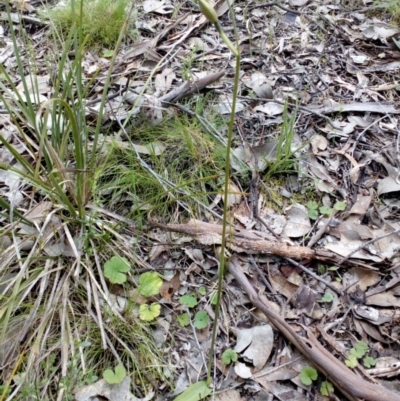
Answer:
96;116;228;218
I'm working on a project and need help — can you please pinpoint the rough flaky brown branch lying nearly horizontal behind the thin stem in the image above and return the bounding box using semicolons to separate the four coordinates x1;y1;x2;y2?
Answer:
151;220;340;263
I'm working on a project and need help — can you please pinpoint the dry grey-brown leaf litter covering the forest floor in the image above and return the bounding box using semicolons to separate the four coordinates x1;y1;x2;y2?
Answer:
0;0;400;400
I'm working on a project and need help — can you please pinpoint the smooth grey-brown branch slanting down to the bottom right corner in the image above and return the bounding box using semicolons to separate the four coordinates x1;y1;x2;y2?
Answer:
229;256;400;401
